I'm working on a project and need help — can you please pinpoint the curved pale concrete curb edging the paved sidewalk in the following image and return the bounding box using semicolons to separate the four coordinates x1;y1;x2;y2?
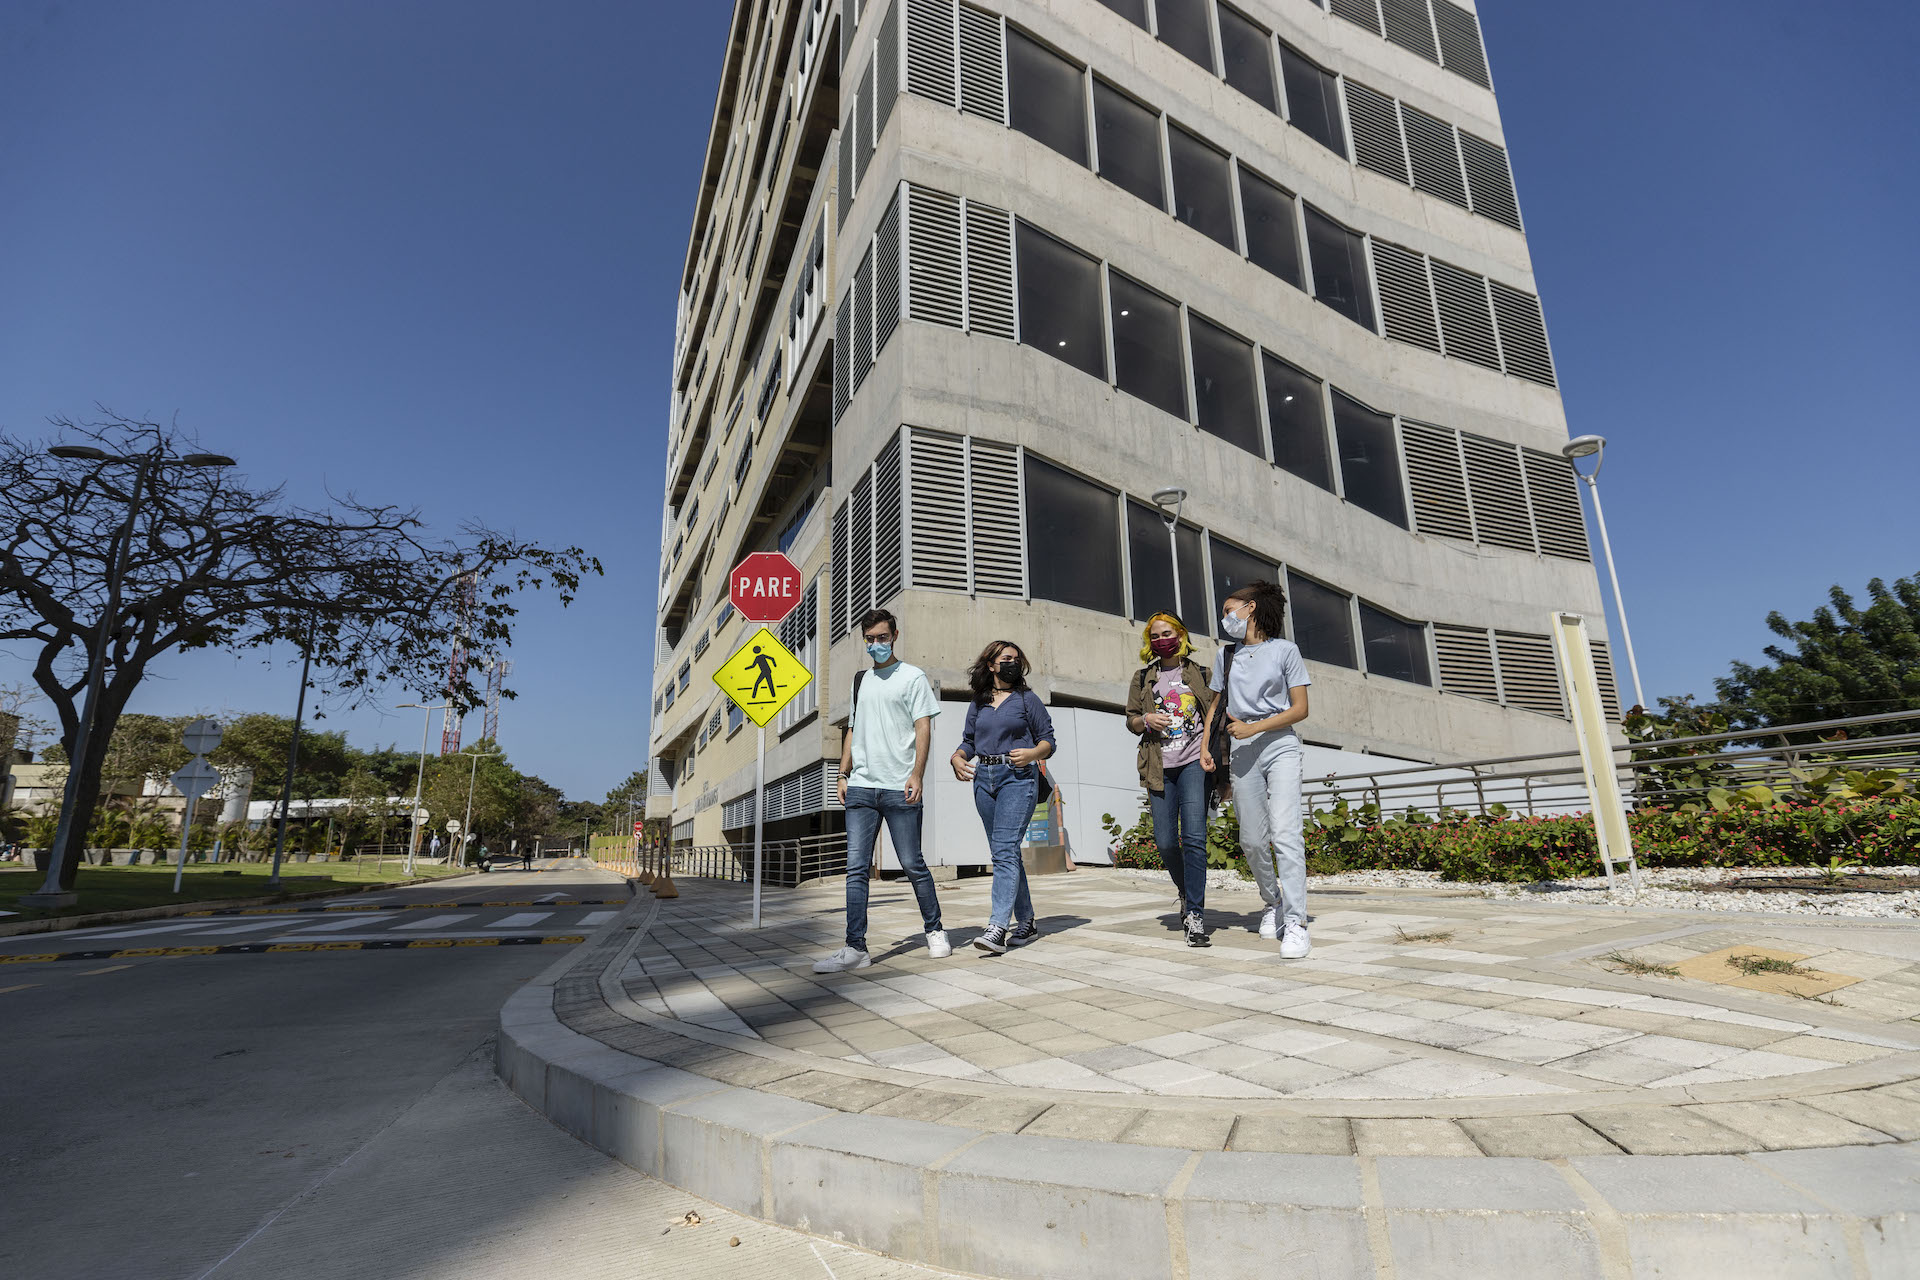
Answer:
497;898;1920;1280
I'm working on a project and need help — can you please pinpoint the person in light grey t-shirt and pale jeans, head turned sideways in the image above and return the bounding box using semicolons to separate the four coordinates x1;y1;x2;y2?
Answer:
1200;581;1313;960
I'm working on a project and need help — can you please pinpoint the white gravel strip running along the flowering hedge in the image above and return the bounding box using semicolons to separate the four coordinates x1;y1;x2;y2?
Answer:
1121;865;1920;919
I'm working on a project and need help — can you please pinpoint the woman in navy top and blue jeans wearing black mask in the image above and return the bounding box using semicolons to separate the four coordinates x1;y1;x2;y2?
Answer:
950;641;1054;956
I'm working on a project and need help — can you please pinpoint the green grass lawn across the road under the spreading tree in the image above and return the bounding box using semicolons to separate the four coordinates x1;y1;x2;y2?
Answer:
0;860;463;923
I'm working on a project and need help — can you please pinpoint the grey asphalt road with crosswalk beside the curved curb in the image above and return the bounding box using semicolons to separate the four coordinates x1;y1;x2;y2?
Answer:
0;869;960;1280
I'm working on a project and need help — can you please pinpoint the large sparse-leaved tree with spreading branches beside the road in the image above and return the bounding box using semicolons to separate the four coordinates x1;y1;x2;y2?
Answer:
0;411;601;889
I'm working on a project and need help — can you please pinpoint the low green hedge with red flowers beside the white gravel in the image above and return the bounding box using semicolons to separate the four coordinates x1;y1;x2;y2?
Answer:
1108;796;1920;883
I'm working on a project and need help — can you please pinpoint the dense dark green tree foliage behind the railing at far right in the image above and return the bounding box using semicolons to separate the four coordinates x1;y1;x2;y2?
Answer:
1713;574;1920;735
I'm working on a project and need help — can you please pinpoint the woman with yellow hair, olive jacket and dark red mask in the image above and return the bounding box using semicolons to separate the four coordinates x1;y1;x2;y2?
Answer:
1127;614;1213;946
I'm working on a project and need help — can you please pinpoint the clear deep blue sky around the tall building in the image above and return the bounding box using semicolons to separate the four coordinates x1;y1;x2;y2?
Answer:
0;0;1920;798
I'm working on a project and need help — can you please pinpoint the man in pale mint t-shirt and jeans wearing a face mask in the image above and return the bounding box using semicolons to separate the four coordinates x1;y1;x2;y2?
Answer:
814;608;954;973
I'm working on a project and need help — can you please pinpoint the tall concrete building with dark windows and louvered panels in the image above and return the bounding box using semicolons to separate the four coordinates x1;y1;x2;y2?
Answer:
647;0;1611;862
